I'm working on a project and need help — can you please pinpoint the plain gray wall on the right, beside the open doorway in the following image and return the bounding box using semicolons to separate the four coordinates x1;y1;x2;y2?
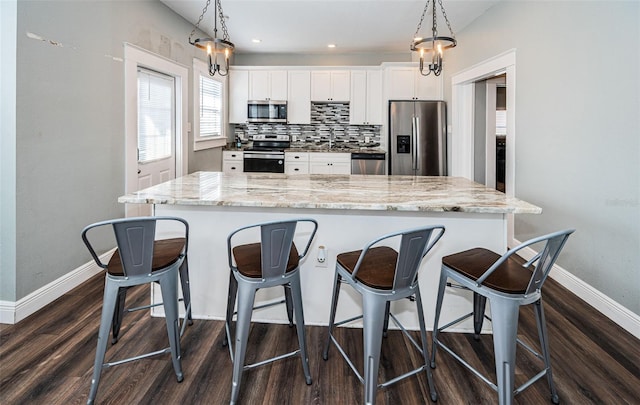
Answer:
445;1;640;314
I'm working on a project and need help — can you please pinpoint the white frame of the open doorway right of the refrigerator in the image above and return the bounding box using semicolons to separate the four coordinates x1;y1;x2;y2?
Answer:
451;49;516;246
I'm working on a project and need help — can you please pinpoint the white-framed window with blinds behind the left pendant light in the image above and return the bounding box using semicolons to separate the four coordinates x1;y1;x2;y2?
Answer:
193;59;227;151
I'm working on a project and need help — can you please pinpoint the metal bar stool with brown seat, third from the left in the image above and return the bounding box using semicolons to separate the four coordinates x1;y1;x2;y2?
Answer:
322;225;444;404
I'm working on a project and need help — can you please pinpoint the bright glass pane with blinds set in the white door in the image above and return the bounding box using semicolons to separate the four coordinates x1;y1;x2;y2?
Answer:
138;69;175;163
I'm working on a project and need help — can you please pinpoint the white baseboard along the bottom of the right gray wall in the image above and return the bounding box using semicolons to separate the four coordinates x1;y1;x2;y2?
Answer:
514;240;640;339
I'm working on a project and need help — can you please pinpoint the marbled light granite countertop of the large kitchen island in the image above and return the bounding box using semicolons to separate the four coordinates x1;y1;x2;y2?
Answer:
118;172;542;214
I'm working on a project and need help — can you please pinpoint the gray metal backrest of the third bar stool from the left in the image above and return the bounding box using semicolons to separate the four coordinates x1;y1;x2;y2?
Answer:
393;226;444;290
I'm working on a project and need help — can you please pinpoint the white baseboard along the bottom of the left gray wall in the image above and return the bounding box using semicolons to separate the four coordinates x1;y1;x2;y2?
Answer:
0;249;115;324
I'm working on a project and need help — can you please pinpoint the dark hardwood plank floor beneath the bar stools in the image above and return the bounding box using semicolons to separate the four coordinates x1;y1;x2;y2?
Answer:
0;276;640;405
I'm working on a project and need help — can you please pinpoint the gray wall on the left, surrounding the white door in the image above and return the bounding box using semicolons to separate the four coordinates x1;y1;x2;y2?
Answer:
6;1;214;301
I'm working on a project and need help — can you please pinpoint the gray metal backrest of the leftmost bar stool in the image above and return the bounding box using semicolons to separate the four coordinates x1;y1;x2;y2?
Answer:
82;217;189;277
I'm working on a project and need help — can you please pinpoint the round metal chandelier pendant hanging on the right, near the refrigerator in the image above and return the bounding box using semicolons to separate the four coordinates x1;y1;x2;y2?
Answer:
411;0;457;76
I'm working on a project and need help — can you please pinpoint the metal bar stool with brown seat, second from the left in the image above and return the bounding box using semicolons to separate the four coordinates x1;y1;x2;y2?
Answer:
223;219;318;404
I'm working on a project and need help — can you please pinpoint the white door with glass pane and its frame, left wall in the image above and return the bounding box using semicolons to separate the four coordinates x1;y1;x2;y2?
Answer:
124;44;189;217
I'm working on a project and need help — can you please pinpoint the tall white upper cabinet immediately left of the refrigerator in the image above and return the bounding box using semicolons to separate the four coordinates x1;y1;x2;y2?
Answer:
349;70;383;125
